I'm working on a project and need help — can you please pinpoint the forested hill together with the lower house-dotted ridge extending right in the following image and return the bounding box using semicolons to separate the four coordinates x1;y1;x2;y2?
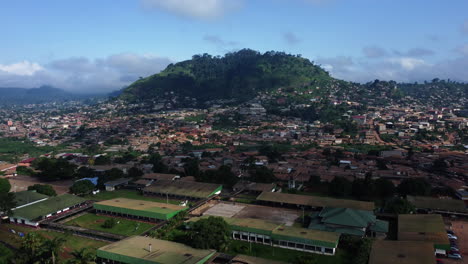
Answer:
120;49;468;108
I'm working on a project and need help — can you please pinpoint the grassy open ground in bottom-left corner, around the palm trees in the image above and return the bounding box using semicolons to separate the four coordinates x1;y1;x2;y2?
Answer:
0;224;109;259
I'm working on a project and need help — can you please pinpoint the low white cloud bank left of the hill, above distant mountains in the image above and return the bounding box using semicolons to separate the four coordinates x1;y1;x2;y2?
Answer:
0;53;171;93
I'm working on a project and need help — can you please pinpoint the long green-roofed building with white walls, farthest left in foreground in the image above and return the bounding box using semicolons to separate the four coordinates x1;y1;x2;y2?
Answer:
10;194;86;227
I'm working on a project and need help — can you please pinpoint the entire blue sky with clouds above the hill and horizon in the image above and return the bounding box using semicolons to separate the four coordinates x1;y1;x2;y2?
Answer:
0;0;468;92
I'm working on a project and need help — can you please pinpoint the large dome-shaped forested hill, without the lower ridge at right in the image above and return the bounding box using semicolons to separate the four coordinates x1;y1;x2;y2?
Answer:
121;49;331;101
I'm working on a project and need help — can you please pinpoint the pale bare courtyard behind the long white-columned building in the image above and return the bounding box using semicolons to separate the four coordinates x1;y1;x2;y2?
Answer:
203;202;302;226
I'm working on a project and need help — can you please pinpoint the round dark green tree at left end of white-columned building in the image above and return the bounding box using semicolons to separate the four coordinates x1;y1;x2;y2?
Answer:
188;216;231;251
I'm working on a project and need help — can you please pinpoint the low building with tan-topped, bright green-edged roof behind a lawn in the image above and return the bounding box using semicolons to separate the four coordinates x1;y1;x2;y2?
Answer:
93;198;188;222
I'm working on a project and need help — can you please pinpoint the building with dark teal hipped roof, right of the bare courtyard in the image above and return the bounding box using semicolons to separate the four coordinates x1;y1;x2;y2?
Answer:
309;207;388;237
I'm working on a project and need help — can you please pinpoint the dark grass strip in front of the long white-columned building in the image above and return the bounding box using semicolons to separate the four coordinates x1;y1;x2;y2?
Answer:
225;240;345;264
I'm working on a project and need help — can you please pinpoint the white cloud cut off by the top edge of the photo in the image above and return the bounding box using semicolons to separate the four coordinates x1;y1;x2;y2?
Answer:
141;0;243;20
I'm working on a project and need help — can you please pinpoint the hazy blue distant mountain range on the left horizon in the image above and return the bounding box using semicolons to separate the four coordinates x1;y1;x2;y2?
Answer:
0;86;103;105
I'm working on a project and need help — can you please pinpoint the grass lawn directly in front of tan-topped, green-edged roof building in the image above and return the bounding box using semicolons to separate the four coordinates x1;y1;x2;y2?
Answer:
65;214;153;236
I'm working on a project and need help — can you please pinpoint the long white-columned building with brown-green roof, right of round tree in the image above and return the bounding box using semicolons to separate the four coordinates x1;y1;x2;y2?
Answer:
189;216;340;255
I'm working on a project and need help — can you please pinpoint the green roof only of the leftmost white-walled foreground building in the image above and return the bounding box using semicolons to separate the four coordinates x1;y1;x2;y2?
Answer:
13;194;86;220
